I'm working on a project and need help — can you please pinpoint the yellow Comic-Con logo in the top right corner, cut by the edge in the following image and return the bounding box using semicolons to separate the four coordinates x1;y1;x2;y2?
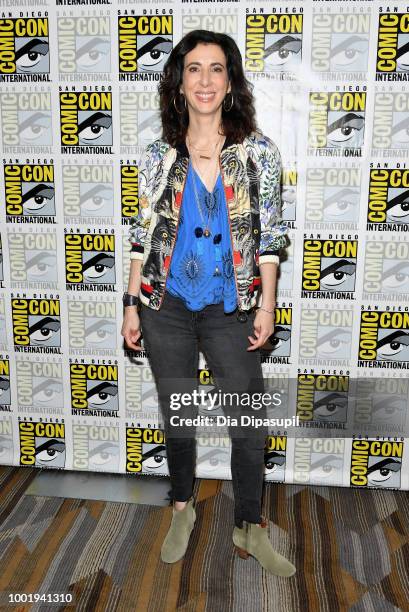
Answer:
376;13;409;81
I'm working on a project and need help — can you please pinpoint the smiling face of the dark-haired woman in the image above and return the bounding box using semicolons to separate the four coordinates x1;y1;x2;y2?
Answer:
180;43;231;116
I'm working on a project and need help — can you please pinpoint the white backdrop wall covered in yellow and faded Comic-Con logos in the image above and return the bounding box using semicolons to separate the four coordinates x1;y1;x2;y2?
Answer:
0;0;409;489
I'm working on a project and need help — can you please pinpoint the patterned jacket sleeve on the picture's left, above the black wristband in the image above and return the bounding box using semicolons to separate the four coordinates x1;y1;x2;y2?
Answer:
129;144;153;259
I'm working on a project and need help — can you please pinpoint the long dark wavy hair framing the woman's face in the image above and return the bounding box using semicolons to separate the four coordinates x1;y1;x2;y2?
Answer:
158;30;257;147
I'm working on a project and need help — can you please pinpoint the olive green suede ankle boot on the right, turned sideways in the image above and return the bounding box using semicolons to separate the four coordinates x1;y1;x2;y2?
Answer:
233;519;296;577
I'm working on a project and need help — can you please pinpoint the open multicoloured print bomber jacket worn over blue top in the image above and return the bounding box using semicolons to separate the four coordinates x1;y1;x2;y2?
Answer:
129;131;288;310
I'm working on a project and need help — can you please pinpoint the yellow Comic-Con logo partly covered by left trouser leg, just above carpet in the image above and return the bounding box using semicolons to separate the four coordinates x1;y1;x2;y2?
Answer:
126;427;168;476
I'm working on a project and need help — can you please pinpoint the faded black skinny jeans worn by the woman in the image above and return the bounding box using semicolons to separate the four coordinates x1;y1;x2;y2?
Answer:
140;292;268;527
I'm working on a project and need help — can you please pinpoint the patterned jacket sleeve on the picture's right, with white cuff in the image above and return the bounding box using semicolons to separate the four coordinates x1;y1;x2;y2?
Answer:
259;136;288;265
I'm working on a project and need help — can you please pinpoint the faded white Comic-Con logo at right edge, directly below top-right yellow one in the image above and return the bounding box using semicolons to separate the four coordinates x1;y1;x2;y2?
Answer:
371;93;409;158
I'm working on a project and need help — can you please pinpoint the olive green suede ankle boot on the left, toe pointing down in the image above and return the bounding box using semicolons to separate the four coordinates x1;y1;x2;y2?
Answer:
160;497;196;563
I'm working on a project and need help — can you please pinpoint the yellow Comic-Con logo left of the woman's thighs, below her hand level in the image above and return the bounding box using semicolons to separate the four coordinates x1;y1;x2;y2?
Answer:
70;361;119;417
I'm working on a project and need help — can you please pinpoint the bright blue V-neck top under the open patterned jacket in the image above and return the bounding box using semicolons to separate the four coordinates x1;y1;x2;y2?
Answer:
166;163;237;312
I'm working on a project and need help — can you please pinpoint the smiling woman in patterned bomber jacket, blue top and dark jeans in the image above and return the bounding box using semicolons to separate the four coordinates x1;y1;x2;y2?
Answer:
121;30;295;576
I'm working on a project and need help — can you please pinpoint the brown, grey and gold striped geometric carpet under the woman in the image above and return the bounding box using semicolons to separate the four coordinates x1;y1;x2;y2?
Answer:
0;466;409;612
